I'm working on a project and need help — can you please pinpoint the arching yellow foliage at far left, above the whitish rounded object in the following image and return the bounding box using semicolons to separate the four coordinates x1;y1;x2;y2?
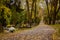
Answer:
0;5;12;24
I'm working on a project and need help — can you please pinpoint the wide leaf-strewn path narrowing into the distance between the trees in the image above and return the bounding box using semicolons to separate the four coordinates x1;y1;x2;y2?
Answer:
0;17;55;40
